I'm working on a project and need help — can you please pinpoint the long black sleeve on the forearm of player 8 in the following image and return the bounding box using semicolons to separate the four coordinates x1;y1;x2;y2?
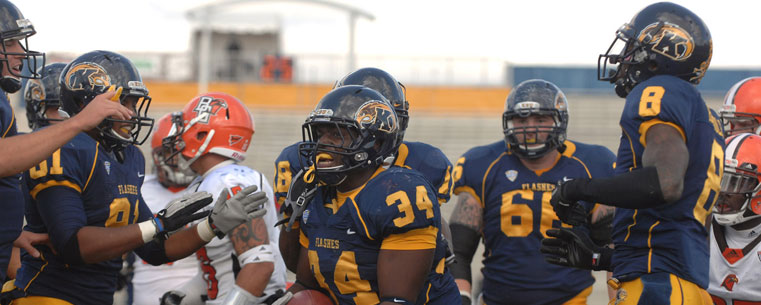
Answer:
563;166;666;209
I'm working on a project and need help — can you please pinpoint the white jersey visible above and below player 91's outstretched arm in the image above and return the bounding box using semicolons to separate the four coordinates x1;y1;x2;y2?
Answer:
132;175;199;305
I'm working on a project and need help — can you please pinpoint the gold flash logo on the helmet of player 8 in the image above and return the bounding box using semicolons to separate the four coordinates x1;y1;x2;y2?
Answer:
637;22;695;61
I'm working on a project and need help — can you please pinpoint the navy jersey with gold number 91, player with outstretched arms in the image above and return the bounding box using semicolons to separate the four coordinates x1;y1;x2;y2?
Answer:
16;133;158;304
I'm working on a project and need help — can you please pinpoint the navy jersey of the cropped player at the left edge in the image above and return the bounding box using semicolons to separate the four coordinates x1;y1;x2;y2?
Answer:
0;90;24;279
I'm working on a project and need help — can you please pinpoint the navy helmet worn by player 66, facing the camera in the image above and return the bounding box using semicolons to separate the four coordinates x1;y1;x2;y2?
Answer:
502;79;568;158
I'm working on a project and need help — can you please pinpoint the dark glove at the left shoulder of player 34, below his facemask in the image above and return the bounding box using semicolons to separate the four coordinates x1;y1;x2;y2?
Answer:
276;169;318;232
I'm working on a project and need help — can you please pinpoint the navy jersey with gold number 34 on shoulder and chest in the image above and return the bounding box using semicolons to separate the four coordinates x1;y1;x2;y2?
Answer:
300;166;460;305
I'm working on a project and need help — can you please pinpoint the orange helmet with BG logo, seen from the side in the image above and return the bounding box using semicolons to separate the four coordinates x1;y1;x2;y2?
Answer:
162;92;254;169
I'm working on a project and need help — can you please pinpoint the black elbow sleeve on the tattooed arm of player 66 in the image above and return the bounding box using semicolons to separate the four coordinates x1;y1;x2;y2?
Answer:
449;223;481;282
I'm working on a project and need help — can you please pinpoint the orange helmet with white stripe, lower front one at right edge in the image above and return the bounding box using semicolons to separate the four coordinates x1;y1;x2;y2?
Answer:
713;133;761;225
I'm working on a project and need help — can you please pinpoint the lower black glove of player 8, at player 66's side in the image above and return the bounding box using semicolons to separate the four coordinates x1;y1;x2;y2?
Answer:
539;228;613;270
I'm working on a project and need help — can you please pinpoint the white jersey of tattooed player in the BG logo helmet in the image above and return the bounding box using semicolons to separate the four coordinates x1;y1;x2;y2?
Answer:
187;161;286;305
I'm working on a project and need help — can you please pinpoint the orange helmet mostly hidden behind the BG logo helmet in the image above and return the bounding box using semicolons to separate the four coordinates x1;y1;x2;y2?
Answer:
151;113;196;187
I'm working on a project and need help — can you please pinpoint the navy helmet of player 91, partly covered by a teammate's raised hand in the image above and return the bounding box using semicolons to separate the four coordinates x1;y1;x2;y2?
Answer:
60;51;153;151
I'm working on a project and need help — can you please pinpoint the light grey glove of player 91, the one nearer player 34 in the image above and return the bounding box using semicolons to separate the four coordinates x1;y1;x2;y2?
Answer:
208;185;268;238
